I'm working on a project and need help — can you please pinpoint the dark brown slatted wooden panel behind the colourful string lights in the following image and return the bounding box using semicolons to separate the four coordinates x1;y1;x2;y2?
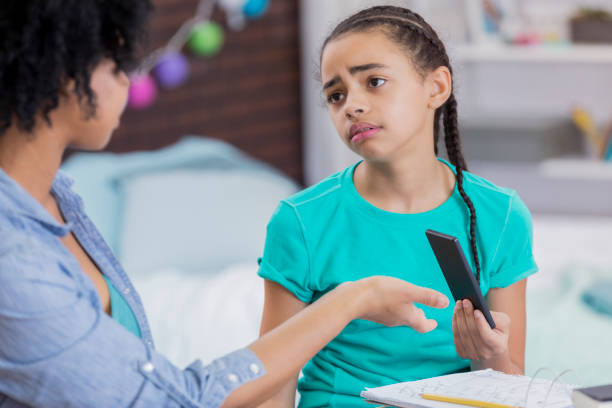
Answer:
107;0;303;183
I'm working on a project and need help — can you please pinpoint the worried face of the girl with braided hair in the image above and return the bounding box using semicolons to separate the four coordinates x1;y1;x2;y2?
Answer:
321;30;437;161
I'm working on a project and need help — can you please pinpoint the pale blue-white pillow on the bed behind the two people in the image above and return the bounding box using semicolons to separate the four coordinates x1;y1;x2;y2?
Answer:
119;169;297;276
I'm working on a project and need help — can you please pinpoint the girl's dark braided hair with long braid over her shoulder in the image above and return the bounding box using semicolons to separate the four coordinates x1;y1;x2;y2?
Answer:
321;6;480;282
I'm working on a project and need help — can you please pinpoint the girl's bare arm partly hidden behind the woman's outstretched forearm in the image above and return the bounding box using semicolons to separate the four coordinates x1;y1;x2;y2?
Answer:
260;280;307;408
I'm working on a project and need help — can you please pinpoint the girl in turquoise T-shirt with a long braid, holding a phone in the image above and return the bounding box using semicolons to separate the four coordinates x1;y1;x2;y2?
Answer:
259;6;537;407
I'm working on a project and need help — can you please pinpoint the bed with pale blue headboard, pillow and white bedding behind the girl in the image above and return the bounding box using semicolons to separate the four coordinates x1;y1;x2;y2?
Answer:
63;136;612;385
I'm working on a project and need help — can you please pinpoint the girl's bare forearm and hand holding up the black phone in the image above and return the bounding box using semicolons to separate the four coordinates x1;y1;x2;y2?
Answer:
453;278;527;374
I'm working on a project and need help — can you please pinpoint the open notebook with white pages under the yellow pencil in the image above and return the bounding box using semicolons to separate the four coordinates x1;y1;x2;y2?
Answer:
361;369;576;408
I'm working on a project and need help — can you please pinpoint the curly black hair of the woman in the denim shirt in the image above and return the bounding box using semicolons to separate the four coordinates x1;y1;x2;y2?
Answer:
0;0;153;135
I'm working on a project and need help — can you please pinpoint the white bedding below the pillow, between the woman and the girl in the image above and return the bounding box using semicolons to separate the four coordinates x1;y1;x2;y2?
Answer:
134;262;264;366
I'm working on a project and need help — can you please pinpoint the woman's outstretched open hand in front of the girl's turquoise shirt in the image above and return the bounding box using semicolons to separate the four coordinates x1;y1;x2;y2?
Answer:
349;276;449;333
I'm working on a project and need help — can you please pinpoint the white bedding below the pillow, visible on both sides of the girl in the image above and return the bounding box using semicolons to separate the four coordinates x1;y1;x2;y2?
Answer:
135;216;612;384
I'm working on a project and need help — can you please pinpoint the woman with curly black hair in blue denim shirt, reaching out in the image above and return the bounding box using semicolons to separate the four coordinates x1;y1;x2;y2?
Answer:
0;0;448;407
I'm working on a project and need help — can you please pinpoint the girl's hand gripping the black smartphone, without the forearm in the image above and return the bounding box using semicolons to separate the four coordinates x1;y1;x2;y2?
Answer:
453;299;510;361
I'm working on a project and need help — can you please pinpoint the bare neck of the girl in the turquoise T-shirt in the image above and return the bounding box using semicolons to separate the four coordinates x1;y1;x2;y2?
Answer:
354;152;455;213
